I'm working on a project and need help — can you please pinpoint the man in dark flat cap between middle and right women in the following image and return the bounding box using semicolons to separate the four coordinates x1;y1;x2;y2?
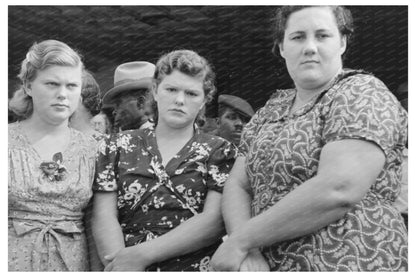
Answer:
213;94;254;146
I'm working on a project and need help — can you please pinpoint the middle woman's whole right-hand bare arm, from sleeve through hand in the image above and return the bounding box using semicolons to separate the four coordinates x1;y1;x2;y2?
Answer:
106;191;223;271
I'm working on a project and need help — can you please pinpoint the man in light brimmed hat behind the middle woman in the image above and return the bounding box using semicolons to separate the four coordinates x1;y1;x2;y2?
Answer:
103;61;155;132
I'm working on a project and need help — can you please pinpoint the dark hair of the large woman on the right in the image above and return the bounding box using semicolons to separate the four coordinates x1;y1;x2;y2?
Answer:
272;5;354;57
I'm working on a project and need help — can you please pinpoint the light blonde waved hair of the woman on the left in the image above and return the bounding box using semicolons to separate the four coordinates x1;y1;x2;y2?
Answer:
9;40;84;119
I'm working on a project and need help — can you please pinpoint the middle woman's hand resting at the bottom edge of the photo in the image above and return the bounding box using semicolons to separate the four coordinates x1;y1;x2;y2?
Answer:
104;245;152;271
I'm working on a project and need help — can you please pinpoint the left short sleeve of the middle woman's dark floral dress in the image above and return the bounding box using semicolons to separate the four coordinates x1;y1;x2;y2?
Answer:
92;134;119;192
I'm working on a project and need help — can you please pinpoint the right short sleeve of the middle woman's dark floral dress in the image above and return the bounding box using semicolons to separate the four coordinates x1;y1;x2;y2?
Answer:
207;139;237;193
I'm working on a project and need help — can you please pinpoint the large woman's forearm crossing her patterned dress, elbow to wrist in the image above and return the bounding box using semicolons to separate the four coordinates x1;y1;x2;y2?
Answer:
233;175;351;250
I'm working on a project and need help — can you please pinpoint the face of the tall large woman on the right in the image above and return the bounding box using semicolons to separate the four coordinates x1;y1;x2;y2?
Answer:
279;7;346;89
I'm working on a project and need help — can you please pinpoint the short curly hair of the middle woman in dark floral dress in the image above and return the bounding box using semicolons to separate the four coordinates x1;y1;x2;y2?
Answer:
147;50;216;124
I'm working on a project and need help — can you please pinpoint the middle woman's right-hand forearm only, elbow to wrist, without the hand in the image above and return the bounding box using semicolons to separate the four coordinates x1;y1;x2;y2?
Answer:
134;209;224;264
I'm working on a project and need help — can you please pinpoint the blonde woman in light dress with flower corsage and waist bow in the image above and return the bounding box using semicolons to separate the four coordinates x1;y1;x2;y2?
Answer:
8;40;96;271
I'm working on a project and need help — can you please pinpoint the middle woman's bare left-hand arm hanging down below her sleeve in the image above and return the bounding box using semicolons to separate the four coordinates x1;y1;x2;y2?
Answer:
92;192;125;265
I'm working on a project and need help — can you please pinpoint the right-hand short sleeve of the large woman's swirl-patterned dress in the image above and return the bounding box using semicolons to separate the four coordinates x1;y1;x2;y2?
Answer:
323;74;407;155
